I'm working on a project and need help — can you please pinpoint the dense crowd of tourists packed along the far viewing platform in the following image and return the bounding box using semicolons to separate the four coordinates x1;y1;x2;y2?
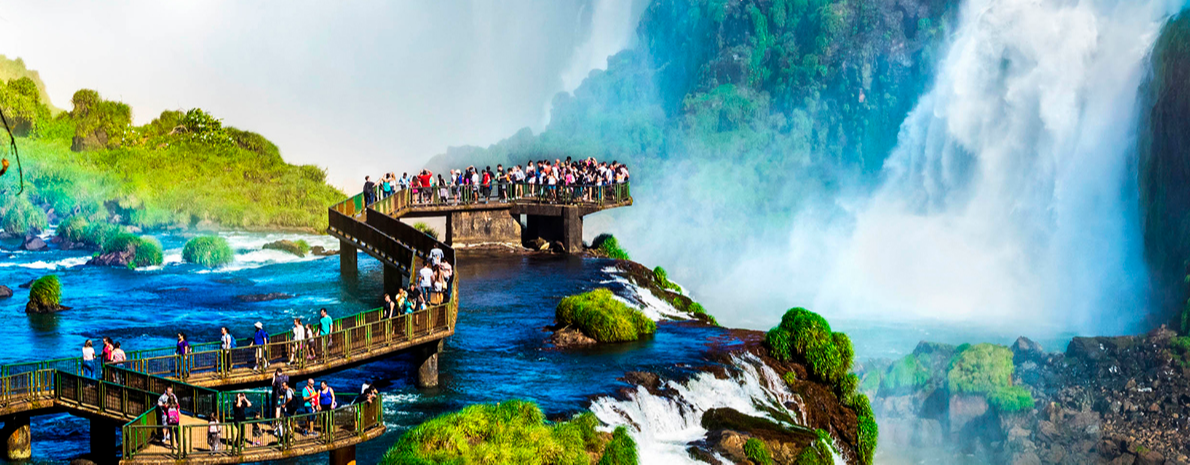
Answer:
363;157;630;205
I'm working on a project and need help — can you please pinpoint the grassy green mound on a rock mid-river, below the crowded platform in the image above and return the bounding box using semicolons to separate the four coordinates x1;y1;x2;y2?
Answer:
556;289;657;343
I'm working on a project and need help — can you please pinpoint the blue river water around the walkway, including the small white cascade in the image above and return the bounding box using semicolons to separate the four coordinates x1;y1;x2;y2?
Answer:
0;228;1090;464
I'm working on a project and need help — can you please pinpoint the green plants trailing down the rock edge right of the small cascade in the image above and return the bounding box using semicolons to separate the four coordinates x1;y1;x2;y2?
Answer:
764;307;879;465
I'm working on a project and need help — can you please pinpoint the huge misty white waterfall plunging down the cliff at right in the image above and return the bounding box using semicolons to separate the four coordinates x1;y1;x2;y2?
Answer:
809;0;1185;332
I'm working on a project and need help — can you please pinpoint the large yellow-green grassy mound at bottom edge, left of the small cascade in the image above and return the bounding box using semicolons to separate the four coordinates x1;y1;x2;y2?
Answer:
381;401;635;465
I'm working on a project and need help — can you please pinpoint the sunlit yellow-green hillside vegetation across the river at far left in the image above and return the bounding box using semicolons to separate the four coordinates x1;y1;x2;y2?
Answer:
0;59;343;233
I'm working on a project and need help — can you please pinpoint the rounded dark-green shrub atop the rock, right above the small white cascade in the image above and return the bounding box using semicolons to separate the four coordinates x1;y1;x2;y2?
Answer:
765;307;854;384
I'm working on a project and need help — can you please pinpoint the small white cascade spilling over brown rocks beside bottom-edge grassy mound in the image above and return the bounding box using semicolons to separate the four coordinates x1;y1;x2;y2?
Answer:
590;353;843;464
